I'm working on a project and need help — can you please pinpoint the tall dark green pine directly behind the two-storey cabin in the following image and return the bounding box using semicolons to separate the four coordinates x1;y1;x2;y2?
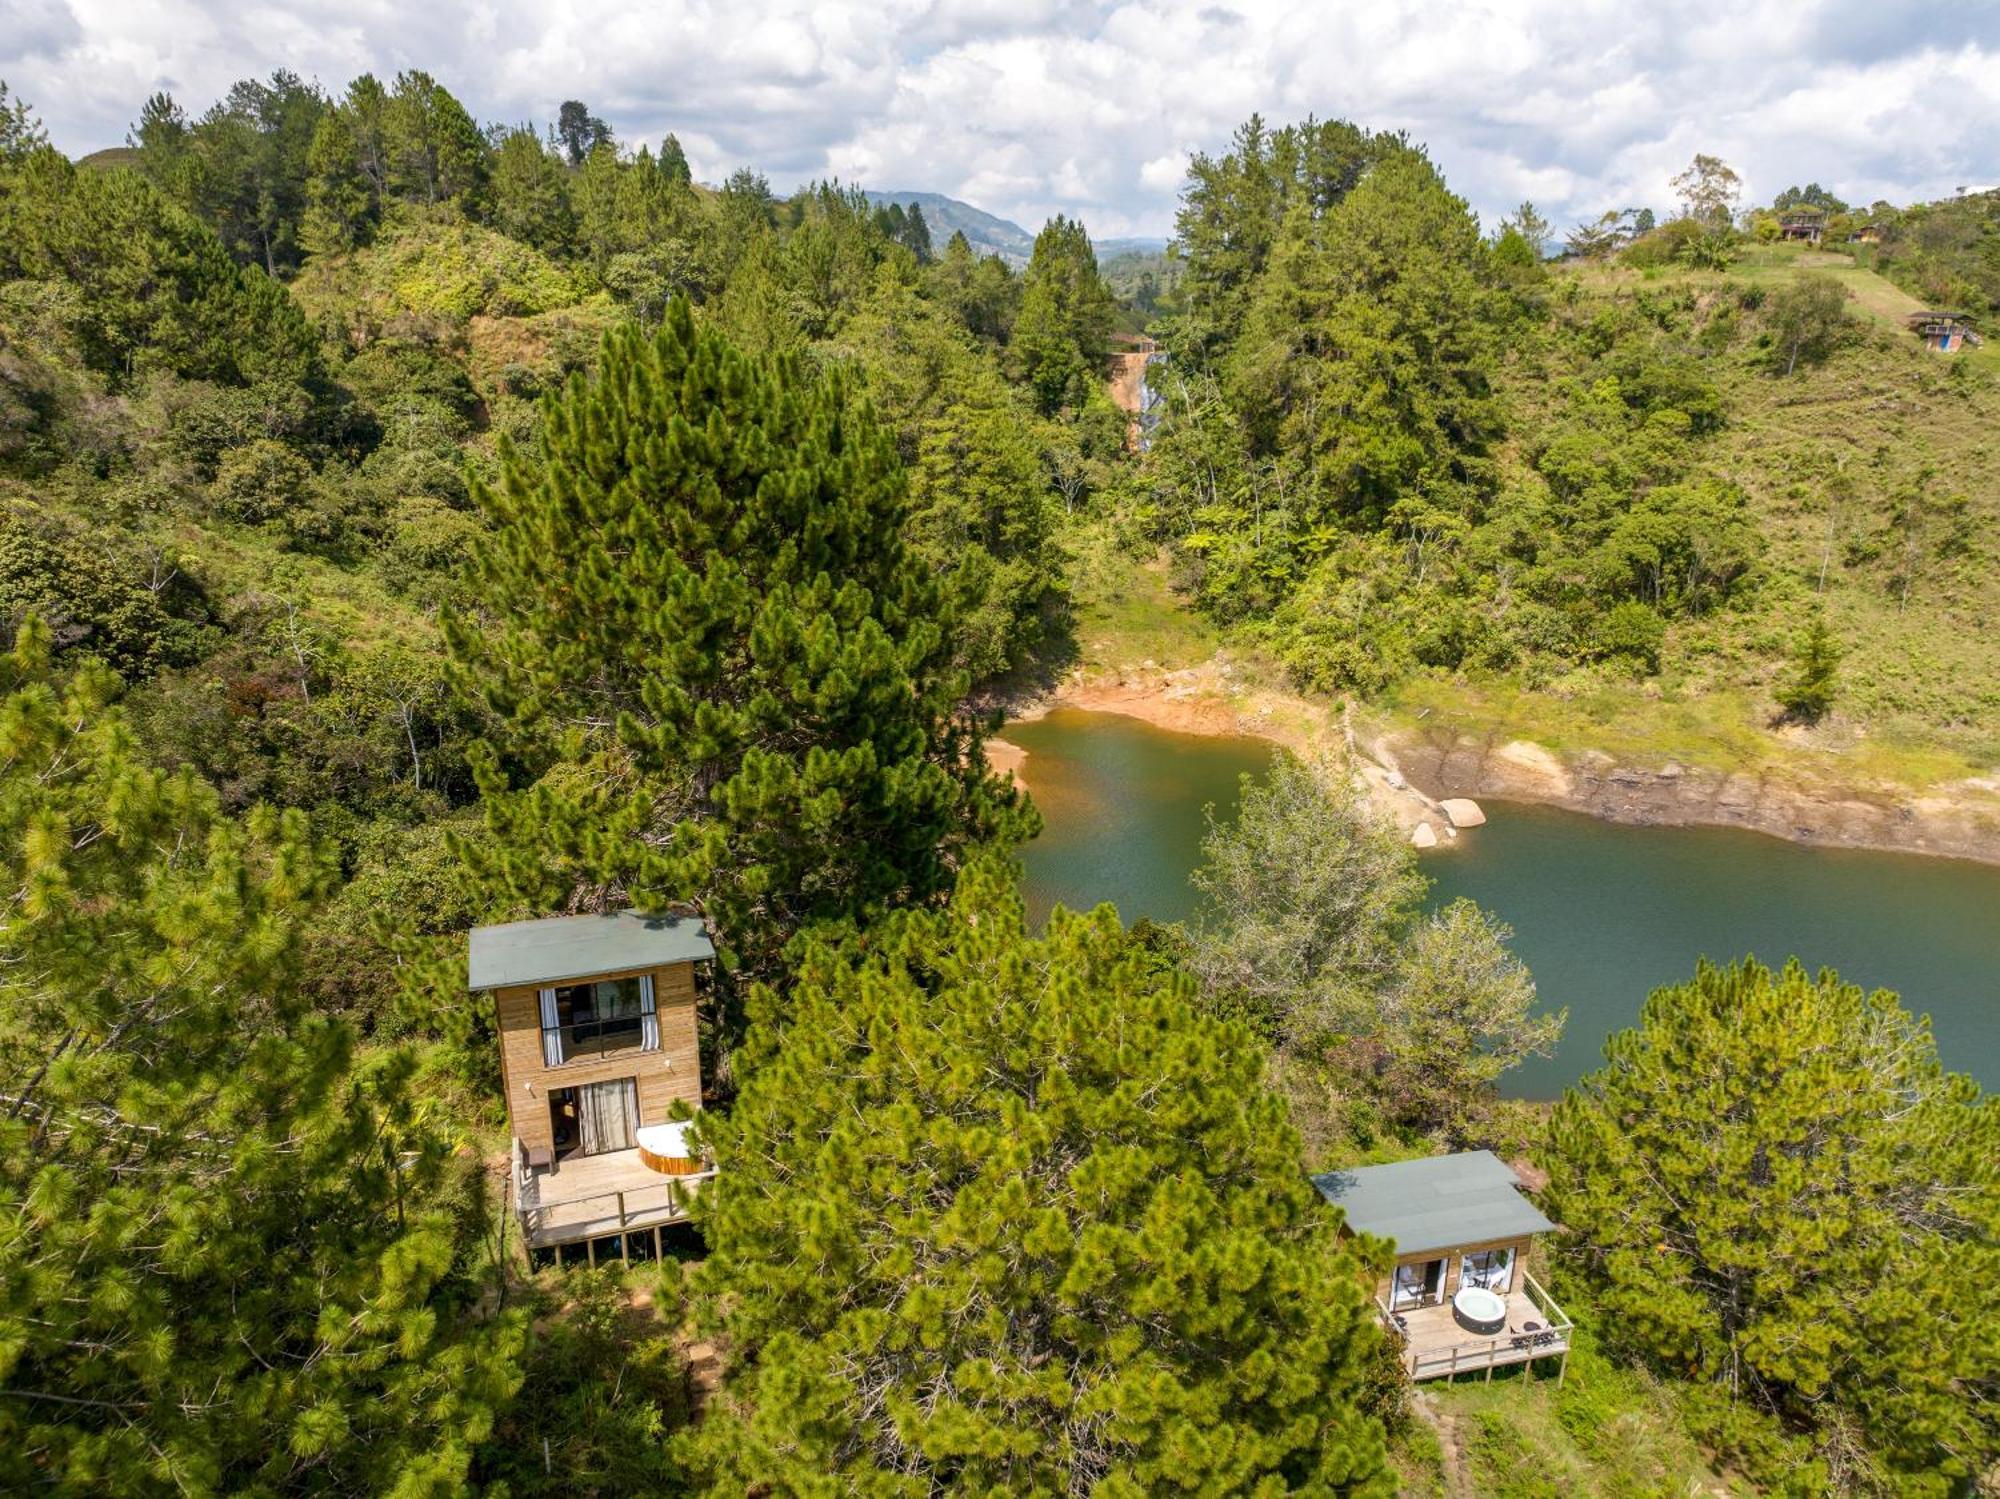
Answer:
448;300;1028;999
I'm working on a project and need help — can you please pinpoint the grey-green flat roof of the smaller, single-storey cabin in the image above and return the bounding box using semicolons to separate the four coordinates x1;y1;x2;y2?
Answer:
1312;1151;1556;1255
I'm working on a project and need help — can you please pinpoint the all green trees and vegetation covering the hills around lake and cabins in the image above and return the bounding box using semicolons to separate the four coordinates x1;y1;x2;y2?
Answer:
0;70;2000;1499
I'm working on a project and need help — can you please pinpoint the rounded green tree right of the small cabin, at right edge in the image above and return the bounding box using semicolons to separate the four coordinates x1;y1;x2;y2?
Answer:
1550;959;2000;1497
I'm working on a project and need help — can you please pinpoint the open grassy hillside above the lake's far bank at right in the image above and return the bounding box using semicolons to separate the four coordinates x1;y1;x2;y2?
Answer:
1394;246;2000;785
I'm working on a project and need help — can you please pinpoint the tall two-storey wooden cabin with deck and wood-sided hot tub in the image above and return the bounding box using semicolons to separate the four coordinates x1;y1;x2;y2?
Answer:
466;911;716;1263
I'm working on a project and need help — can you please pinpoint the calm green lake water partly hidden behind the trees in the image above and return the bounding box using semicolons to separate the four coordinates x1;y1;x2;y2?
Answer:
1002;710;2000;1097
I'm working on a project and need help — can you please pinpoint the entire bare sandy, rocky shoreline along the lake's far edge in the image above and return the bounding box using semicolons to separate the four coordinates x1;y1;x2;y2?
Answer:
988;658;2000;865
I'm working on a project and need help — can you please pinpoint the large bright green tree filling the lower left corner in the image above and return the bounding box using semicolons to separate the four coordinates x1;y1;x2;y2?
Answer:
0;624;522;1493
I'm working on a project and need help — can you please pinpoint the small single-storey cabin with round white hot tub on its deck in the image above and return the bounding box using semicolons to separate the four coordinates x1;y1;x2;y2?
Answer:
1312;1151;1570;1383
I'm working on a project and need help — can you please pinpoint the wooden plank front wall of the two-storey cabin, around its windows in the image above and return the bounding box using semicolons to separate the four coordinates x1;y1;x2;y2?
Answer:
494;963;702;1149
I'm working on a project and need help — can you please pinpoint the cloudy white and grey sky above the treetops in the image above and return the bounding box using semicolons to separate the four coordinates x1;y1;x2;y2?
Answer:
0;0;2000;238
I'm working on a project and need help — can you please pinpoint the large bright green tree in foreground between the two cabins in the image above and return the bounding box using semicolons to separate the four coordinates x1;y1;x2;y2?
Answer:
698;861;1390;1495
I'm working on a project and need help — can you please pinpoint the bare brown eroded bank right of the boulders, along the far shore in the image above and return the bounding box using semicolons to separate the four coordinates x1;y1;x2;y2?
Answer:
1372;730;2000;863
